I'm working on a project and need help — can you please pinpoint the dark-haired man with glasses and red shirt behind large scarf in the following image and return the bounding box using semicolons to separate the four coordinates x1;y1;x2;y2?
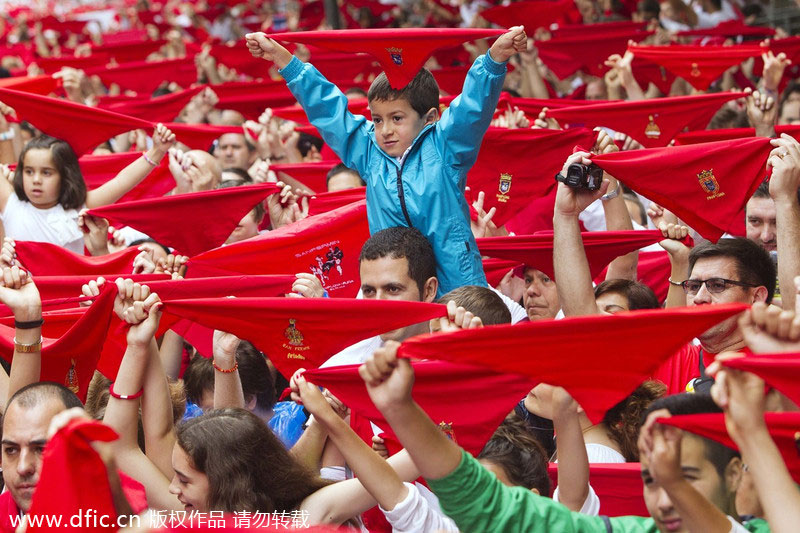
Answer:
671;238;776;391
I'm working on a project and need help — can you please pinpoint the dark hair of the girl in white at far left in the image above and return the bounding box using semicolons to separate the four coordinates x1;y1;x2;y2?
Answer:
14;135;86;209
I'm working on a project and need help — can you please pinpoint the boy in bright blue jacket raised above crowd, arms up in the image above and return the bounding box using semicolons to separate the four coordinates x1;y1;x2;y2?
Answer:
247;26;527;294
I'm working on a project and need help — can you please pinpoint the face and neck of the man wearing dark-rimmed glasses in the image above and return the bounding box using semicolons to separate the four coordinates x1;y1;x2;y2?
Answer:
686;257;756;345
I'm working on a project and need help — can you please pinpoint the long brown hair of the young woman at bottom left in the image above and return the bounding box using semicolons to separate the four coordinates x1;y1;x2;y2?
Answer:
177;409;331;513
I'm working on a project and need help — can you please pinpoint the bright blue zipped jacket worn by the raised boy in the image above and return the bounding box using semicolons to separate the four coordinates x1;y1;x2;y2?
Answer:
280;53;506;295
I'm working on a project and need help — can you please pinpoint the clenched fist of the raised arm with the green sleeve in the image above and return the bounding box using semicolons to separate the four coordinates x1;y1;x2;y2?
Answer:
358;341;414;411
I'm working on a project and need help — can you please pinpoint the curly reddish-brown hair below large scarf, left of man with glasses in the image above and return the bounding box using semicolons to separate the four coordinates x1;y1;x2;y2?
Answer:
603;380;667;463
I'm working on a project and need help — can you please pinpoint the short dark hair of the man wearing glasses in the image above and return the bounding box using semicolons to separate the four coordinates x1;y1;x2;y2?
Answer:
689;238;777;303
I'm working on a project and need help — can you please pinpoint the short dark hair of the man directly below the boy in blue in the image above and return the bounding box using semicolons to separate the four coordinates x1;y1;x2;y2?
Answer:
358;226;436;295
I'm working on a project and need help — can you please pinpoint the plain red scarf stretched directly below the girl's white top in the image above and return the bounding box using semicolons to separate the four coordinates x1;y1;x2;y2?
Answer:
16;241;139;276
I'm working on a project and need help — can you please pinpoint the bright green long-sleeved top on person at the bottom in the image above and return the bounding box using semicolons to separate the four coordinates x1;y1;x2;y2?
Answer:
428;452;769;533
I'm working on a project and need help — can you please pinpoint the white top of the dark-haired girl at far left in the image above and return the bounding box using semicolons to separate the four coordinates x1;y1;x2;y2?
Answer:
0;192;83;254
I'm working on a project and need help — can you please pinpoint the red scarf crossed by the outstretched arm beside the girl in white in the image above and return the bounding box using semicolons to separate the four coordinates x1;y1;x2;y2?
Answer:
78;152;175;202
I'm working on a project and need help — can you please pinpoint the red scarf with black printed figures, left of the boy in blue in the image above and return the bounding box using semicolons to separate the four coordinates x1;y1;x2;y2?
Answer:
188;202;369;297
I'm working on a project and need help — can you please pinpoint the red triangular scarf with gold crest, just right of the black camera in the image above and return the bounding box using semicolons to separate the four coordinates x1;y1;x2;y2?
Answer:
592;137;772;242
